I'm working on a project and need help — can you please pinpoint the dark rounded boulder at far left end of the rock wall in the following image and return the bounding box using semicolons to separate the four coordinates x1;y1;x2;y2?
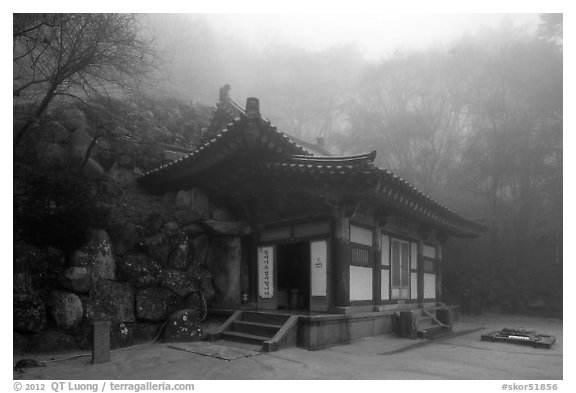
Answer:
12;294;46;333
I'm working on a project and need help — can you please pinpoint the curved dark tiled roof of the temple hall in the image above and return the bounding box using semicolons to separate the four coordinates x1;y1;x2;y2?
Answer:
138;89;486;235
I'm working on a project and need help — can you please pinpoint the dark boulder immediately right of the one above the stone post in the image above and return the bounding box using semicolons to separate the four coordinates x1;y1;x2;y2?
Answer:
136;288;180;321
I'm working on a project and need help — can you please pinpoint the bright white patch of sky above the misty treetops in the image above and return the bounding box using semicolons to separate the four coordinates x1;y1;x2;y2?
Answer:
205;13;538;59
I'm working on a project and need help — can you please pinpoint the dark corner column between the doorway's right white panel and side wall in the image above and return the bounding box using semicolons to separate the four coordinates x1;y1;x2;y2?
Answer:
330;215;352;308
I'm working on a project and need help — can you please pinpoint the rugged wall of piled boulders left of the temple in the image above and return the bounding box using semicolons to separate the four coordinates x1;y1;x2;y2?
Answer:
13;96;251;352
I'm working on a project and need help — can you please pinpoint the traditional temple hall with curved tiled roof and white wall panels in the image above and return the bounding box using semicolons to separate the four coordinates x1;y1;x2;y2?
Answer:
138;86;485;349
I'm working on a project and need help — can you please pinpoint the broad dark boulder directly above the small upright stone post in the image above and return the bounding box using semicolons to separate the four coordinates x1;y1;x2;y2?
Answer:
85;280;136;322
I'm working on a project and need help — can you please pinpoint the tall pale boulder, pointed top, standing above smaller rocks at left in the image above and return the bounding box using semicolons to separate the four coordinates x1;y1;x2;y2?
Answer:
70;229;116;282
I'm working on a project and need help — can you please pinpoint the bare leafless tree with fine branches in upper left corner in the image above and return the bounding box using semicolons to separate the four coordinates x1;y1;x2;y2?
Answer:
13;14;155;146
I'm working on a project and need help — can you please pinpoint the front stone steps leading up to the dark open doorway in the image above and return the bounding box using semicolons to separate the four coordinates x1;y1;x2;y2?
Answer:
207;311;298;352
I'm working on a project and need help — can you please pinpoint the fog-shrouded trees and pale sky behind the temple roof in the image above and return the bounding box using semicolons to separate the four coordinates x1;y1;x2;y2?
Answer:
141;14;563;309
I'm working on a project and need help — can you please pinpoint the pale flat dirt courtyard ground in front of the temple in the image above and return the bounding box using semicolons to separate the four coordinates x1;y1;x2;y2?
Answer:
13;314;563;380
